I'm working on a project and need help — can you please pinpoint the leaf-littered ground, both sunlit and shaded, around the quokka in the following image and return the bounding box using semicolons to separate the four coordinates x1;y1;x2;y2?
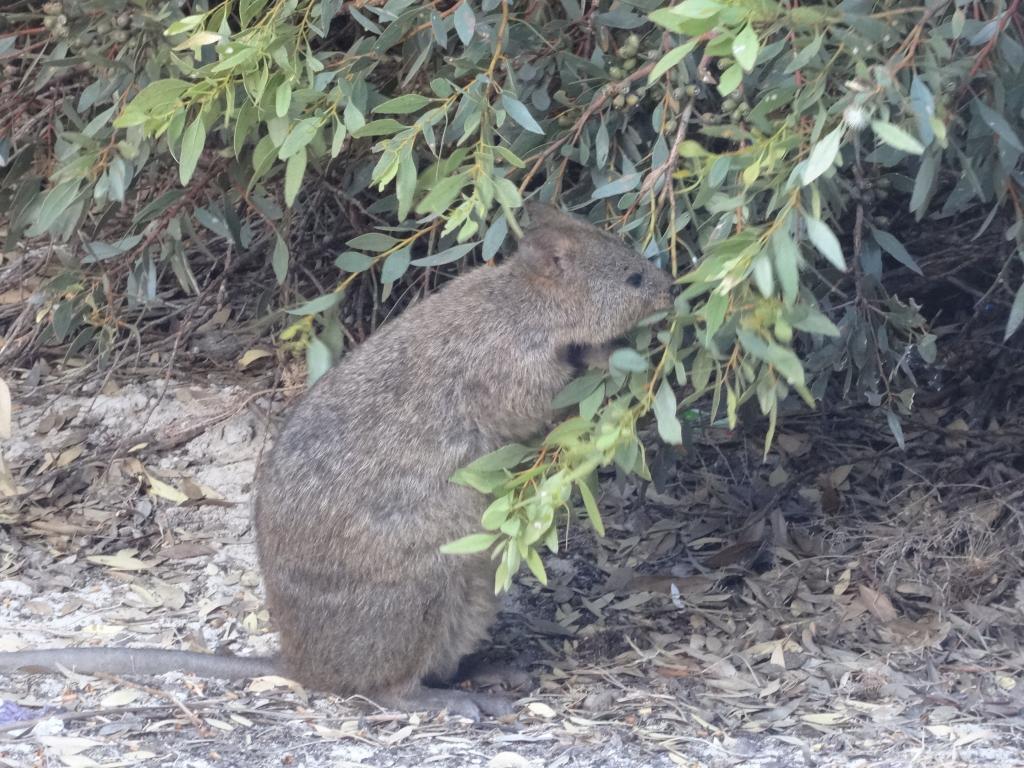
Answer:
0;356;1024;768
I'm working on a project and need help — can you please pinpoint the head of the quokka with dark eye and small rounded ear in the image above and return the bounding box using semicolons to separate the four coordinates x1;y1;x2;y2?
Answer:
513;203;673;343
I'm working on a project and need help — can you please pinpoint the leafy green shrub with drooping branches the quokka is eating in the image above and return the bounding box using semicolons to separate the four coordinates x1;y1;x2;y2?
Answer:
0;0;1024;587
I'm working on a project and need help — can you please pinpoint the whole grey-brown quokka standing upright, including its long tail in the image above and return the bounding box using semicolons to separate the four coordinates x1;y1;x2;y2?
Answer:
0;201;671;717
